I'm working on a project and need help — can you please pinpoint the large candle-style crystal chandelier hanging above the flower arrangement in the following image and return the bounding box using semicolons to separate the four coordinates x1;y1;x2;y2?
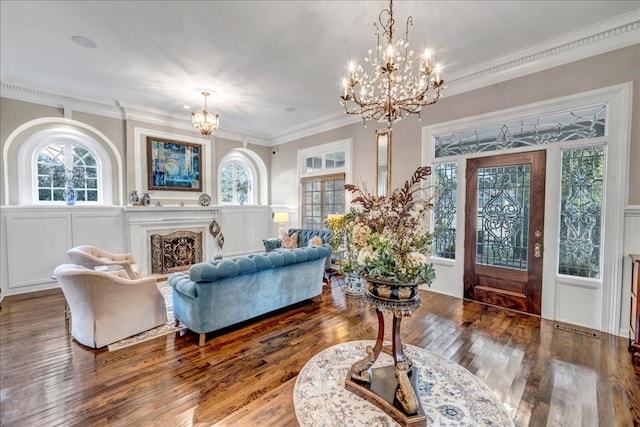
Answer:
340;0;444;127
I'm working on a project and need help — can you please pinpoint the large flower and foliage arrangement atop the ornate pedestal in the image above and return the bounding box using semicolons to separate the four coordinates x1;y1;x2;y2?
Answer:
343;166;435;285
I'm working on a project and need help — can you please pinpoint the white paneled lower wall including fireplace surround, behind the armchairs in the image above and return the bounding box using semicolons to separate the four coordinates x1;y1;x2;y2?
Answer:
0;205;274;299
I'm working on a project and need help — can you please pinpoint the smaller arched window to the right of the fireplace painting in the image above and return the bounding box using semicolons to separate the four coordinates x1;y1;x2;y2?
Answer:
219;157;255;205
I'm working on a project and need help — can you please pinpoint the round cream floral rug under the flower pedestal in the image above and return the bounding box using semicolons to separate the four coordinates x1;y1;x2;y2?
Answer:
293;341;514;427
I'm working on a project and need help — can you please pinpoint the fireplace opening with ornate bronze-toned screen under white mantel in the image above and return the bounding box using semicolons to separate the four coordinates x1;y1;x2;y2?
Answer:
149;230;202;274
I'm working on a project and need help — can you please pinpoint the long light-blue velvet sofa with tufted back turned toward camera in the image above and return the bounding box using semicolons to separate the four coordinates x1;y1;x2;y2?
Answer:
168;245;331;346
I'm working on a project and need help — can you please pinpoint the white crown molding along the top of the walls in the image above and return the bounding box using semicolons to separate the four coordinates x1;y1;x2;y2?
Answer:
0;11;640;146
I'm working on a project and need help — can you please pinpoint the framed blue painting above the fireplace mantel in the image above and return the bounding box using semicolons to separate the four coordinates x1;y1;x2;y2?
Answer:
147;136;202;191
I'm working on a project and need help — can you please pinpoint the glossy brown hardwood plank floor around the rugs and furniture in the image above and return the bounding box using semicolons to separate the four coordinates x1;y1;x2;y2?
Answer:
0;282;640;427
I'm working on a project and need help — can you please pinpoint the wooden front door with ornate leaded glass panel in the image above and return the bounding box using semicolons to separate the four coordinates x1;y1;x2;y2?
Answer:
464;151;546;315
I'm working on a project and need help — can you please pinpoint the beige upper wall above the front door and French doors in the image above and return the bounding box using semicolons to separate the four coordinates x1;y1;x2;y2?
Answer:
271;44;640;206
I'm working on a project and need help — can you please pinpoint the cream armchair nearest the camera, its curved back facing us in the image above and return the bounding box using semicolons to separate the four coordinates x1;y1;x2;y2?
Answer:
54;264;167;348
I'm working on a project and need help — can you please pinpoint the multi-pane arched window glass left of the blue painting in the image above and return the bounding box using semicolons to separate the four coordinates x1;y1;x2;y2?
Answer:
36;140;99;202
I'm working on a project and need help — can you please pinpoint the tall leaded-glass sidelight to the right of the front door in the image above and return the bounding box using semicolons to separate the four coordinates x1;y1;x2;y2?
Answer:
558;147;605;279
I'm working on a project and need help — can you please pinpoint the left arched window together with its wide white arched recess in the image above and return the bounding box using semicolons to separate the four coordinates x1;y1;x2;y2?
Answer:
10;123;122;206
